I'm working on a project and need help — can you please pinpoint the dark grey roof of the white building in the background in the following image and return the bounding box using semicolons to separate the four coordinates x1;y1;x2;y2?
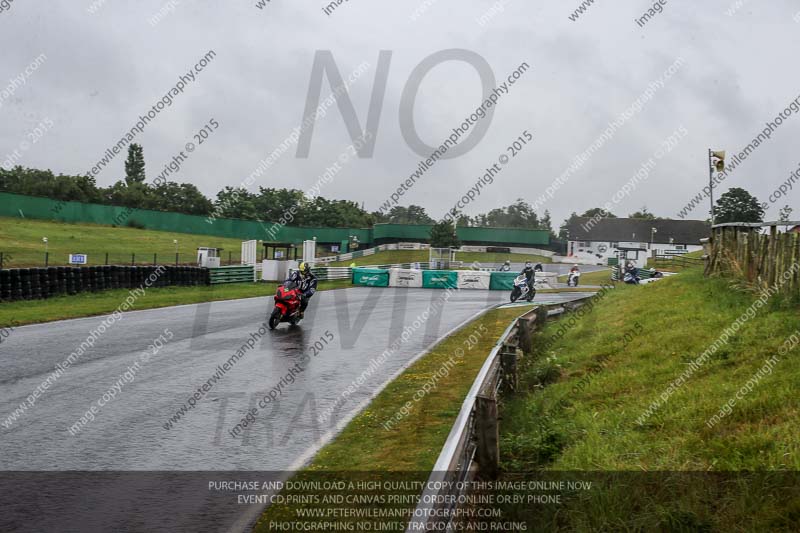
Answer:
567;217;711;245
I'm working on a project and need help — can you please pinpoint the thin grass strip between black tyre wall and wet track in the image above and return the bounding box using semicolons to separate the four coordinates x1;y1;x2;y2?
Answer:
0;280;350;327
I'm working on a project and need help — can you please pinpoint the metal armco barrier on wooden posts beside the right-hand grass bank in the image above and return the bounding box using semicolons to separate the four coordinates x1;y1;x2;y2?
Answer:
406;300;583;533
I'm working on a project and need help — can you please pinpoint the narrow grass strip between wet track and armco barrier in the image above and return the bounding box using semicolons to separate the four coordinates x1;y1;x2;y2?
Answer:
256;308;527;532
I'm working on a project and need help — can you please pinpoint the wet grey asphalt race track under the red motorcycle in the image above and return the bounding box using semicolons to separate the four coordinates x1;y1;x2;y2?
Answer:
0;288;596;531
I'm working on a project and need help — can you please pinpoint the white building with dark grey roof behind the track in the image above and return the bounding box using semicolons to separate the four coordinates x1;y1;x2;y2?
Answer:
567;217;711;268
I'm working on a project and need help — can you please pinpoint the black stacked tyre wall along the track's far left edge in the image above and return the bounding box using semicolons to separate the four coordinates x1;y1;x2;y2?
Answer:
0;265;209;301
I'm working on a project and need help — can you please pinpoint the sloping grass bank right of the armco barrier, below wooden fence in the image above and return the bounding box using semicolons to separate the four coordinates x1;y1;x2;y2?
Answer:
494;268;800;531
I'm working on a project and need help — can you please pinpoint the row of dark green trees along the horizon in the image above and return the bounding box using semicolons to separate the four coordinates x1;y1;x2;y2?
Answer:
0;144;780;232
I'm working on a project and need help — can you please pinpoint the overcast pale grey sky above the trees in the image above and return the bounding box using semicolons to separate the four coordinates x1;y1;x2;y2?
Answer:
0;0;800;225
